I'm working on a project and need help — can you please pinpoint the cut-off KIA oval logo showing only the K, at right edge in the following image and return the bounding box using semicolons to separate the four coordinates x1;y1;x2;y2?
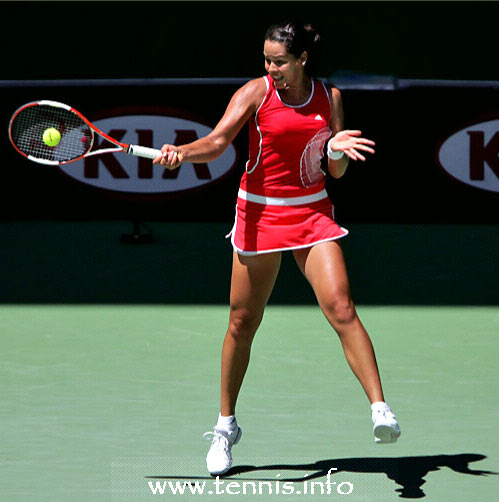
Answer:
438;119;499;192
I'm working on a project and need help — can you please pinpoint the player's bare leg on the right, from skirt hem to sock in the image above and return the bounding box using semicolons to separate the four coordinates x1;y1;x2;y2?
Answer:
294;241;384;403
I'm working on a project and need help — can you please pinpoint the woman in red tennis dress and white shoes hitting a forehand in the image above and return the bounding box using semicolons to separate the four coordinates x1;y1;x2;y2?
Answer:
154;23;400;476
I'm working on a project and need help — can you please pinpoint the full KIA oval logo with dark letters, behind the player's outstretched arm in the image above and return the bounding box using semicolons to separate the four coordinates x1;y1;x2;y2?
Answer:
59;115;236;194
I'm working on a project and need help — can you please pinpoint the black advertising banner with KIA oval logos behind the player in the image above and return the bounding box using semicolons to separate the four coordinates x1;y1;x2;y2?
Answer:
0;79;499;223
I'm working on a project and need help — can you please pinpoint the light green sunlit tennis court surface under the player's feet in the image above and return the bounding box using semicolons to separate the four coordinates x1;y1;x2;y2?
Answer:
0;305;499;502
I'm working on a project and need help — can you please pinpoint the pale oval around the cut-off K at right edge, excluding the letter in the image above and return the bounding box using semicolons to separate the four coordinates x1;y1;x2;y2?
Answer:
437;119;499;192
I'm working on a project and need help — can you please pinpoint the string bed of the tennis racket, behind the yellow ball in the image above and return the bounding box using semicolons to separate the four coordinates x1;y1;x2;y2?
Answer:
11;105;93;162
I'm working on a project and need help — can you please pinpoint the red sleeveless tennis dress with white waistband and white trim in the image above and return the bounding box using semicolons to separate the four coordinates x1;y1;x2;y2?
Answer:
230;75;348;255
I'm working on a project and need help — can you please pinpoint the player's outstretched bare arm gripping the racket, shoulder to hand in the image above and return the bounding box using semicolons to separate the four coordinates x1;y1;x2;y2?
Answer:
153;78;266;169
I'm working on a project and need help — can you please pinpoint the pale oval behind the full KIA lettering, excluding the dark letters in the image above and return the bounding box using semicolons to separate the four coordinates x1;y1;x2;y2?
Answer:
59;113;237;195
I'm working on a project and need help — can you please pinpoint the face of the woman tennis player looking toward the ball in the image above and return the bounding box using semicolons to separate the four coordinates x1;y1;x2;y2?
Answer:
263;40;307;89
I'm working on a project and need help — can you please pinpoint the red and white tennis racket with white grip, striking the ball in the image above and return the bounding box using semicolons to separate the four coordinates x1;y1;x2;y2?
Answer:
9;100;181;166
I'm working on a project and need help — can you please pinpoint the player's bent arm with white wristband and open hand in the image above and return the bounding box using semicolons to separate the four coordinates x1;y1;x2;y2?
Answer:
327;87;375;178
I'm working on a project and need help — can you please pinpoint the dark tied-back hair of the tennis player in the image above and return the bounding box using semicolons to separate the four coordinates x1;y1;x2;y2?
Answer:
265;21;321;76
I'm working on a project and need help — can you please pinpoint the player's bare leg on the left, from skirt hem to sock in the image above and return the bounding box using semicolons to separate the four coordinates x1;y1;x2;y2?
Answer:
220;252;281;416
